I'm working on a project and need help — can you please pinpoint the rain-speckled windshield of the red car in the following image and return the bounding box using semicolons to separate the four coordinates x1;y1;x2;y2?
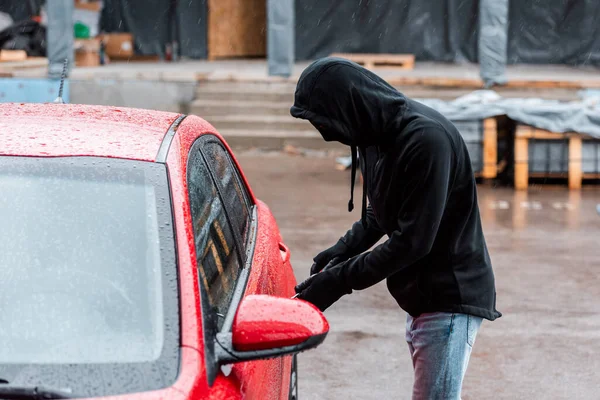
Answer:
0;157;179;396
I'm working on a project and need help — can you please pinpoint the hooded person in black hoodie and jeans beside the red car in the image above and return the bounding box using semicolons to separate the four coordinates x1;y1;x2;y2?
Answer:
290;57;501;399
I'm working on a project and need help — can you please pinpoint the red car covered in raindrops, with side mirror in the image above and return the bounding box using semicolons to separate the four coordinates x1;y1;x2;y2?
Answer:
0;104;329;400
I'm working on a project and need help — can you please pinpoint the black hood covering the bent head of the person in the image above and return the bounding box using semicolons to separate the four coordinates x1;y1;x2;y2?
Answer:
290;57;406;148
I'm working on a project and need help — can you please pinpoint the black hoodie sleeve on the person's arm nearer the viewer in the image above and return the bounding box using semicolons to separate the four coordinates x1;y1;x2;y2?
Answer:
340;127;454;290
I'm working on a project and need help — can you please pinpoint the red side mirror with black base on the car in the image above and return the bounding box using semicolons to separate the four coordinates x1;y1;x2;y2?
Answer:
215;295;329;365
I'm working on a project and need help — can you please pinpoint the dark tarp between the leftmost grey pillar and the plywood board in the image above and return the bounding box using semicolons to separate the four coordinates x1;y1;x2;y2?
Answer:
100;0;208;58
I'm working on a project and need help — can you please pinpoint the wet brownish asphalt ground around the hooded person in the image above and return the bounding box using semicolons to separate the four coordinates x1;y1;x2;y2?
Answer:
238;152;600;400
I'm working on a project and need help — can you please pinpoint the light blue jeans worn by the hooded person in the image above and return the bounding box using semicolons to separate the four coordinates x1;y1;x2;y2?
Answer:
406;312;482;400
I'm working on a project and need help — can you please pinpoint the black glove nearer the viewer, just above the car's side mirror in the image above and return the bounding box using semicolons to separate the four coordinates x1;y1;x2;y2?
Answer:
295;263;352;311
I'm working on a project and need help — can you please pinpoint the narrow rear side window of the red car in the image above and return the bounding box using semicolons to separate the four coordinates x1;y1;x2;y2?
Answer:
202;141;251;246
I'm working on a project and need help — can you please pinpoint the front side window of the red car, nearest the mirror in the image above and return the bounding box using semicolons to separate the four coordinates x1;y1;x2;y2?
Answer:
187;146;243;329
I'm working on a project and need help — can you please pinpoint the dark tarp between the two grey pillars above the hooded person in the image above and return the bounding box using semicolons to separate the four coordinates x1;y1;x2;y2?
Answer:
296;0;479;62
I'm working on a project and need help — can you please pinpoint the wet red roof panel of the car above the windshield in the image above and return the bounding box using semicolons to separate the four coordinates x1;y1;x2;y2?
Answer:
0;103;179;161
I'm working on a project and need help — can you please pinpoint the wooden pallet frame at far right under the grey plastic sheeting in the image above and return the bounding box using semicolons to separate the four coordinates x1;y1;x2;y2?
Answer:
514;125;600;190
